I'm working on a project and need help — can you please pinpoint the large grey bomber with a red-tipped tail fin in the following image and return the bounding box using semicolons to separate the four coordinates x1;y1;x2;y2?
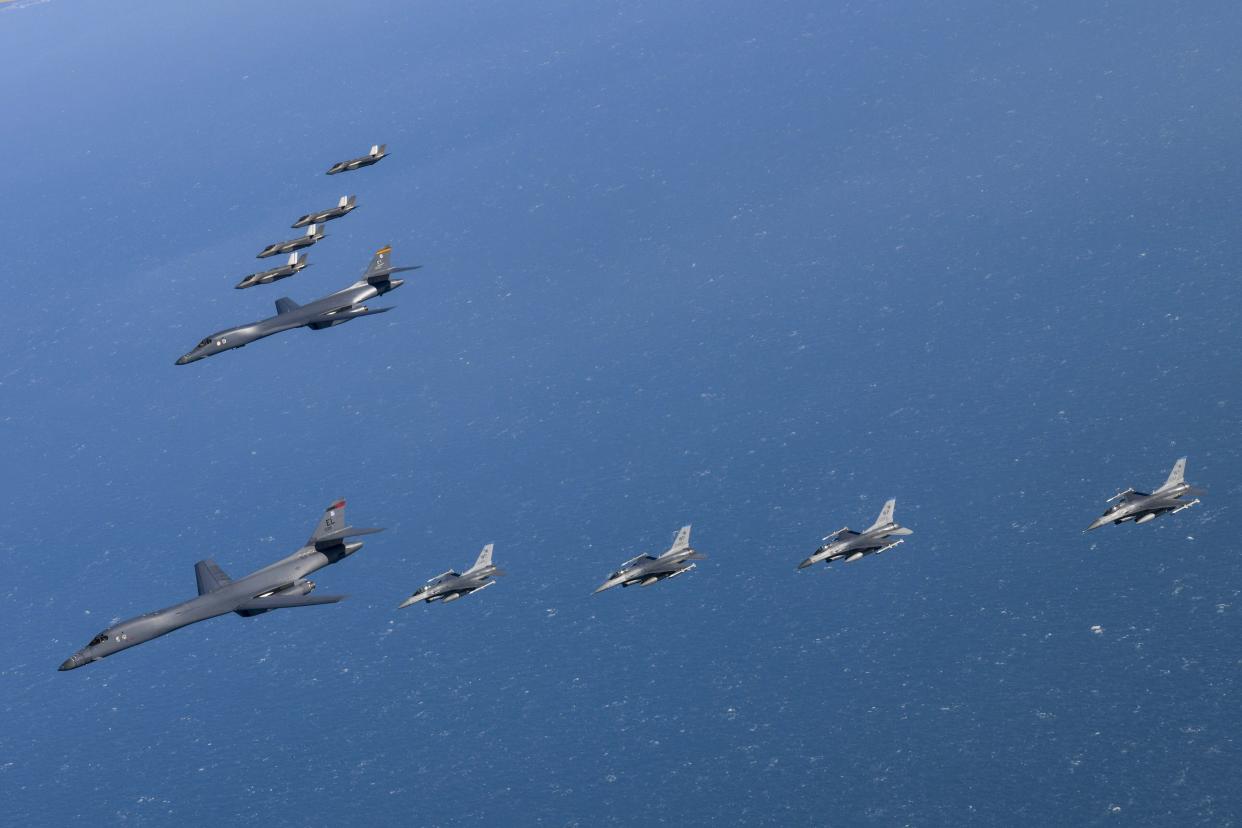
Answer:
61;500;383;670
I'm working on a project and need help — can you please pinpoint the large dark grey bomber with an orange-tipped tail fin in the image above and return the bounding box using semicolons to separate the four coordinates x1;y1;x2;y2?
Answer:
176;247;422;365
